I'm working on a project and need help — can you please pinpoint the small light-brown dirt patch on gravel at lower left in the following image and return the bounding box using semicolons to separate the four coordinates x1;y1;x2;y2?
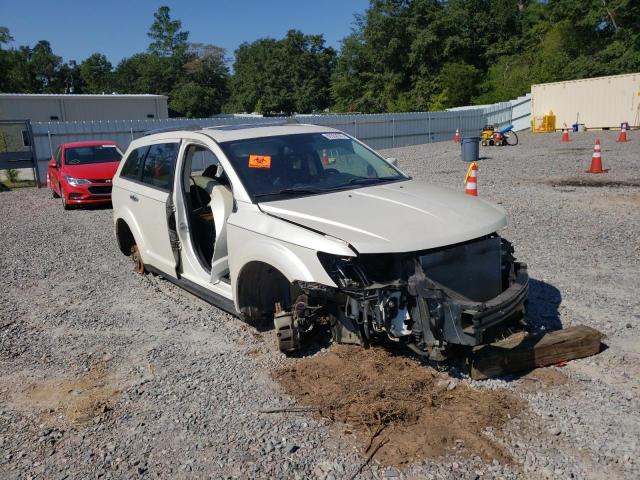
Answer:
21;365;121;424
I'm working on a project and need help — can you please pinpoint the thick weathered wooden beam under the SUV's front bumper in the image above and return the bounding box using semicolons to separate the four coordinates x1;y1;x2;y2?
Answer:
469;325;602;380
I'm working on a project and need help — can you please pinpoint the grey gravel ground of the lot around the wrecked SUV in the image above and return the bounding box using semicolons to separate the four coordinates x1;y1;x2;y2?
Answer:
0;132;640;479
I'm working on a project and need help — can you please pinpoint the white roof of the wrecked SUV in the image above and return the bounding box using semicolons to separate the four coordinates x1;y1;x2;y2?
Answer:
143;123;340;143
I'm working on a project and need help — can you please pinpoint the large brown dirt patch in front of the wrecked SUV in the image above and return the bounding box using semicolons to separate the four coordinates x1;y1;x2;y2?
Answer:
274;345;523;465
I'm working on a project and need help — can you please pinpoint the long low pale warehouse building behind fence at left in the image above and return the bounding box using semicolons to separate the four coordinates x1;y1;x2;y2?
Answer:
0;93;169;122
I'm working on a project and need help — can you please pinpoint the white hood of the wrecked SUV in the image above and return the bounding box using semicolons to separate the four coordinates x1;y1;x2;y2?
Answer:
259;180;507;253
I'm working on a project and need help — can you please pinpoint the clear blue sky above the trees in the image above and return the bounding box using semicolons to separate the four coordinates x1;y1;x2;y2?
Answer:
0;0;369;66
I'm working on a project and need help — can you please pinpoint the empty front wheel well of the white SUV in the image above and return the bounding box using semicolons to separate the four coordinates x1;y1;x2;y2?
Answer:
237;261;291;322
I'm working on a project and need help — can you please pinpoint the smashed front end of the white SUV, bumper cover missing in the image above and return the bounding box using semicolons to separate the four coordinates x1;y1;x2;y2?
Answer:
276;234;529;358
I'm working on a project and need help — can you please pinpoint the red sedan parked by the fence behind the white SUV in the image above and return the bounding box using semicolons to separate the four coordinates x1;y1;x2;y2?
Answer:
47;141;122;210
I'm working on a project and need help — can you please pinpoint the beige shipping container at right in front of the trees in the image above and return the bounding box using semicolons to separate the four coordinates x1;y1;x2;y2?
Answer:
531;73;640;129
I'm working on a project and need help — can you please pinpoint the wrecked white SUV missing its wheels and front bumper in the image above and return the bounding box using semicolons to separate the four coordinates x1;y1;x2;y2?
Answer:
112;123;528;358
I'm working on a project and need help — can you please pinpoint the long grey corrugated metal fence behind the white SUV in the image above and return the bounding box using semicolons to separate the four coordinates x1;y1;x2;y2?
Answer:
32;99;530;178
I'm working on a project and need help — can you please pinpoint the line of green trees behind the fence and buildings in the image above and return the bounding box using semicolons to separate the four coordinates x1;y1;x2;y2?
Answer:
0;0;640;117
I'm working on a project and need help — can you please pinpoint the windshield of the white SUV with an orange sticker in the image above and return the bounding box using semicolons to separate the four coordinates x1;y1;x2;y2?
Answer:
220;132;407;201
